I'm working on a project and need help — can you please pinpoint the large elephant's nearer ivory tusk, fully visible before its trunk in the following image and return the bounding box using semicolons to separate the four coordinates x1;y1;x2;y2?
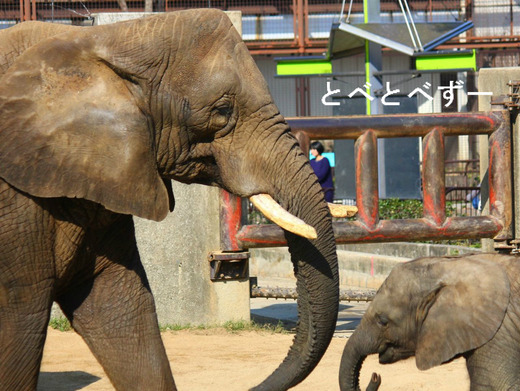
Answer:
249;194;318;239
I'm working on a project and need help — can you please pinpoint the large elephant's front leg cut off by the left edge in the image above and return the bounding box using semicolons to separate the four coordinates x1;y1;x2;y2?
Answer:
0;184;54;391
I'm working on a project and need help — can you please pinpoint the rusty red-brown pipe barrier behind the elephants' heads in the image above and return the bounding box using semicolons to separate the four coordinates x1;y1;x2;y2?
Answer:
220;110;513;252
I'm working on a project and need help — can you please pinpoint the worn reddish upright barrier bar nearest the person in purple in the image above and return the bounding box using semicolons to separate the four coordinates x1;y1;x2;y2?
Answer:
354;130;379;230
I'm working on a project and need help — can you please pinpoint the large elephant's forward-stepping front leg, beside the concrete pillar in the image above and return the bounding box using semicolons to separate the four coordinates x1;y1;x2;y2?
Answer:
58;234;176;391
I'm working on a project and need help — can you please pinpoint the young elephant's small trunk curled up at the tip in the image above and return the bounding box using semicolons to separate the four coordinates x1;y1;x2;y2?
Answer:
339;322;381;391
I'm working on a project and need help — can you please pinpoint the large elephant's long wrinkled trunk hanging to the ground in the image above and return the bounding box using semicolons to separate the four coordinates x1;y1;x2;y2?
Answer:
253;136;339;391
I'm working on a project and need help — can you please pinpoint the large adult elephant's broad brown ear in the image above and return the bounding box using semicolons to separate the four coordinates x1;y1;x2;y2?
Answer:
0;34;173;220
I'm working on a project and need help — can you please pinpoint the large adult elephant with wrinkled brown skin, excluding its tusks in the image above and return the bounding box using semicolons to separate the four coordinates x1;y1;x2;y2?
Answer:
0;10;338;391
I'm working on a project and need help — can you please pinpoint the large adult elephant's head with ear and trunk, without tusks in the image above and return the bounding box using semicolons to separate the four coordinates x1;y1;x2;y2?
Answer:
0;10;338;390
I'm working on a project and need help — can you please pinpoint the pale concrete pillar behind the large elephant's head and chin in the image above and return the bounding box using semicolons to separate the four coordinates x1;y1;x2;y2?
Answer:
94;12;250;325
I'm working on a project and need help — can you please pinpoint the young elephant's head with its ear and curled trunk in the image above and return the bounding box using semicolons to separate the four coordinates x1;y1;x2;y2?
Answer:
339;255;510;391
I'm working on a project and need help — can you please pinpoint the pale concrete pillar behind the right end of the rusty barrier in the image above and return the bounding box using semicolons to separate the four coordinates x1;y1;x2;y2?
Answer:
478;68;520;251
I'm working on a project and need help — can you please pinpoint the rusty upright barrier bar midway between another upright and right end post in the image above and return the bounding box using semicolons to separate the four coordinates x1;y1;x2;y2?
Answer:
422;128;446;226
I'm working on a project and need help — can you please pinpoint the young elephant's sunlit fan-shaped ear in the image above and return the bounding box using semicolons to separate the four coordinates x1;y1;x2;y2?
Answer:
416;255;510;370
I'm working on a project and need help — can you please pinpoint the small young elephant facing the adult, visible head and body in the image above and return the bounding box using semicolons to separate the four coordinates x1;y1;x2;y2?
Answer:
340;254;520;391
